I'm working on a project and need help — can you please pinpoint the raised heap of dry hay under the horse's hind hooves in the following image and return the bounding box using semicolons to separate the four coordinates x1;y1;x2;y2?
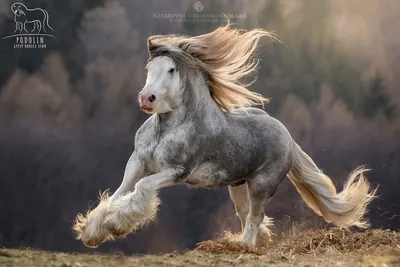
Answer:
196;228;400;255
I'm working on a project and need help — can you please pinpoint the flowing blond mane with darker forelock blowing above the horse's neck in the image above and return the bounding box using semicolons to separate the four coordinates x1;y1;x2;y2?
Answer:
148;24;276;111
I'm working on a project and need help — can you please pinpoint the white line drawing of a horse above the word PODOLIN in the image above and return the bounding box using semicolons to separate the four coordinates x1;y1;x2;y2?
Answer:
11;2;53;34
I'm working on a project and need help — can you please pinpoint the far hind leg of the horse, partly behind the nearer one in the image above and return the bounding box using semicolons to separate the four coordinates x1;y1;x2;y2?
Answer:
229;183;249;231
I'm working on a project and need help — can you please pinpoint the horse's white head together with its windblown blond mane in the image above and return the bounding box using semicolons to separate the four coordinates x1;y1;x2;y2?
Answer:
139;25;275;113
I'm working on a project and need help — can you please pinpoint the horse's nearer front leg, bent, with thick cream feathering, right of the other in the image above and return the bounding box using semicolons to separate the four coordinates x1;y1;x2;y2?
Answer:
105;168;184;240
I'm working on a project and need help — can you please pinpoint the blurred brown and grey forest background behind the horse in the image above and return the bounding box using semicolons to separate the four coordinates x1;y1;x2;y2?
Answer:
0;0;400;253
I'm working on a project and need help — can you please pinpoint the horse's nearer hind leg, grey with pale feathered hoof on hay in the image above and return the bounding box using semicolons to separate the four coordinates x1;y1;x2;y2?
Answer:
242;172;286;245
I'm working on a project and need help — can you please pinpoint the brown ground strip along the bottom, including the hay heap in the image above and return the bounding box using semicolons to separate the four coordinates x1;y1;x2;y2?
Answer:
0;229;400;267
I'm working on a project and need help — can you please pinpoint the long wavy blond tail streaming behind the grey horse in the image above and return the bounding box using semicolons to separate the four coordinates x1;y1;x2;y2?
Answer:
288;143;377;228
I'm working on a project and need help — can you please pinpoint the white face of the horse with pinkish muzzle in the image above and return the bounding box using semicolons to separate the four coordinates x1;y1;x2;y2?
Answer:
139;56;181;113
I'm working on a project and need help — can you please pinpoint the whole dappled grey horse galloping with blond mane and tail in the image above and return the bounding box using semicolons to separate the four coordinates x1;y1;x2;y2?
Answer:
74;25;375;247
